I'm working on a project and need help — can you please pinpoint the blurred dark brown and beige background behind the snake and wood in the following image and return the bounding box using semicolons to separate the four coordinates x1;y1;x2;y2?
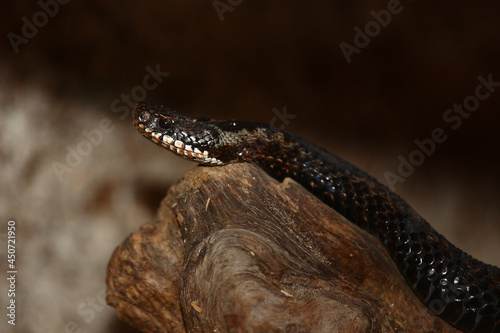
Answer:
0;0;500;332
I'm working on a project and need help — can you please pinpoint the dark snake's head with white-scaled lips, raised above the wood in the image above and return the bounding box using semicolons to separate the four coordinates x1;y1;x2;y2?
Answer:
134;103;225;165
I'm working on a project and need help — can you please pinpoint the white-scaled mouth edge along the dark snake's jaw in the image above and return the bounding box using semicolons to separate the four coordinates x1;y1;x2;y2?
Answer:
134;120;224;165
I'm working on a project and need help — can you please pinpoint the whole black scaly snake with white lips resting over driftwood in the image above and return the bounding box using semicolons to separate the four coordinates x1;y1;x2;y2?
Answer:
133;103;500;332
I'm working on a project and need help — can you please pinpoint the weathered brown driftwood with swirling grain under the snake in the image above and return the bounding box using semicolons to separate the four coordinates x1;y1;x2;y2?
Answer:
106;164;456;332
